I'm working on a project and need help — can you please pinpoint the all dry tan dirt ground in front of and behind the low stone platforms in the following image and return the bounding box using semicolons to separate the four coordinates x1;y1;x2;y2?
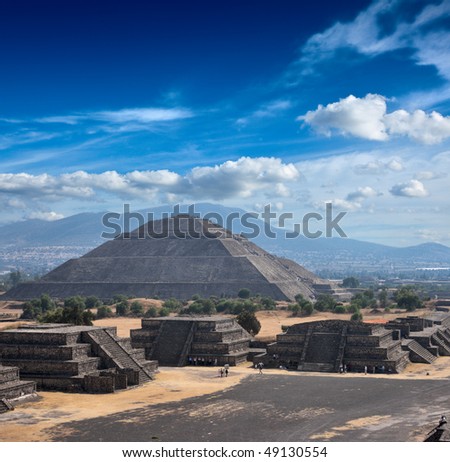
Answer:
0;305;450;441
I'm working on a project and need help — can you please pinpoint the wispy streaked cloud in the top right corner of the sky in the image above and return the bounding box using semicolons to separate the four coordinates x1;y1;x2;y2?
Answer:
294;0;450;83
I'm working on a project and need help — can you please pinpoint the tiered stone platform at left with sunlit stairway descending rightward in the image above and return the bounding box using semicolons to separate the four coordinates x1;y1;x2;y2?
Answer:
0;324;157;393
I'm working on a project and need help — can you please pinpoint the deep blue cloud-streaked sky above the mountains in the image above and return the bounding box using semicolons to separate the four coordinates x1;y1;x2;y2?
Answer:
0;0;450;246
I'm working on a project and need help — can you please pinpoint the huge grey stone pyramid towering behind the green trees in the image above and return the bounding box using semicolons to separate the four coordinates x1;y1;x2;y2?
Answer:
4;215;330;300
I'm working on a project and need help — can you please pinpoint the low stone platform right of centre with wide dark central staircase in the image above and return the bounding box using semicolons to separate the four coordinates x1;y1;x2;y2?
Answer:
254;320;409;373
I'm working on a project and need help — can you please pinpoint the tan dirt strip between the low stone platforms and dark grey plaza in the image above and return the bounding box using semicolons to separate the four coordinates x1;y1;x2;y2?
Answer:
0;357;450;442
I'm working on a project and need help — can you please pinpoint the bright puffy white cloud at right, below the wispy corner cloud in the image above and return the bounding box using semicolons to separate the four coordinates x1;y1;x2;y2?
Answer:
298;93;450;143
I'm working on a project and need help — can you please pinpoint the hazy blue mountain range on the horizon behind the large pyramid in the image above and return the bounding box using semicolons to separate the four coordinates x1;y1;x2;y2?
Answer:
0;203;450;275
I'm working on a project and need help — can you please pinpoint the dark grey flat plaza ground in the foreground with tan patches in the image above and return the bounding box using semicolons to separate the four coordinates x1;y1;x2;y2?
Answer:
49;374;450;442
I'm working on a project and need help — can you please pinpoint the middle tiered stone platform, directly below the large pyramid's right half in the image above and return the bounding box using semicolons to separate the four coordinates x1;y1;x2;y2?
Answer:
131;316;251;366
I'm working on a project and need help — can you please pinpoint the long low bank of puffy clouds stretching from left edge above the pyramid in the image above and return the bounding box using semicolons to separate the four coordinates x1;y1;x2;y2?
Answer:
0;157;299;204
